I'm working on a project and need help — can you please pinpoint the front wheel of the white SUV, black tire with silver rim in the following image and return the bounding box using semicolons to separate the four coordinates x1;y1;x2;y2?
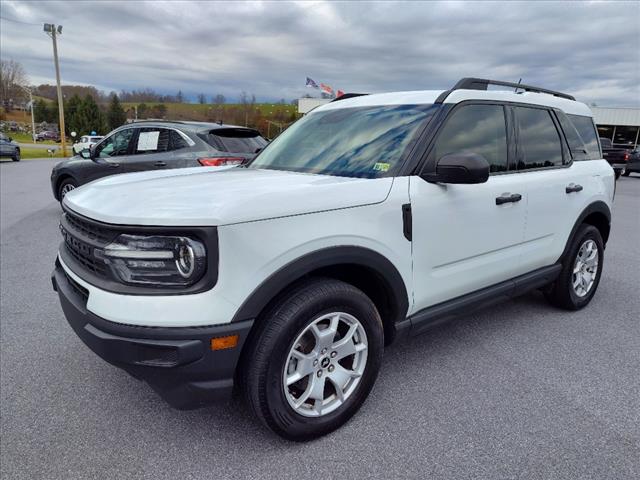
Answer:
241;278;384;441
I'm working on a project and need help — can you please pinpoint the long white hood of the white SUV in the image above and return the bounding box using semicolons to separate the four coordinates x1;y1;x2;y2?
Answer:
64;167;393;226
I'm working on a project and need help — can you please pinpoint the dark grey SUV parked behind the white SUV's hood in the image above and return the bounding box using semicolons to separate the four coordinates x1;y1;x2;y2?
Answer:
51;121;268;201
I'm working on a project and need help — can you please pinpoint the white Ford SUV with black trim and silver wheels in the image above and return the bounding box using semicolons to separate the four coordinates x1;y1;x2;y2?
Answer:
53;79;614;440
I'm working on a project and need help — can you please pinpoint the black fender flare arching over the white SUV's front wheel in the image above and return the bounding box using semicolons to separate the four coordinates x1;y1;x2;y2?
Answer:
232;246;409;322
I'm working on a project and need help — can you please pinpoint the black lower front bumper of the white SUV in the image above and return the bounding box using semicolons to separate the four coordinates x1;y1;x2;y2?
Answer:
51;261;253;409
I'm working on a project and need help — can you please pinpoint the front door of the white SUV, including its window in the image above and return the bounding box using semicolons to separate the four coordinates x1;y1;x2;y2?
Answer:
409;104;527;312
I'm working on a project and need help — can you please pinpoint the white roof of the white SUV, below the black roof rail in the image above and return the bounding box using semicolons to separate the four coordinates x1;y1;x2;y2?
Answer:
313;89;592;117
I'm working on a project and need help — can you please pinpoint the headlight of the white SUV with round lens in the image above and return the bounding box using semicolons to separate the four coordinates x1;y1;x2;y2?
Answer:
95;234;207;286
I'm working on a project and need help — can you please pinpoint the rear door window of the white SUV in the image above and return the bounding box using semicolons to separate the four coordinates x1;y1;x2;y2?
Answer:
515;107;562;170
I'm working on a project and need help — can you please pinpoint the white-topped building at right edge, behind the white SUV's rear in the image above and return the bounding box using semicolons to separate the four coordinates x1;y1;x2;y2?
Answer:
591;107;640;149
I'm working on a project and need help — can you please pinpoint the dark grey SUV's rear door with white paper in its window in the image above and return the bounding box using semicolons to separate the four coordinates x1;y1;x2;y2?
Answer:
124;127;188;172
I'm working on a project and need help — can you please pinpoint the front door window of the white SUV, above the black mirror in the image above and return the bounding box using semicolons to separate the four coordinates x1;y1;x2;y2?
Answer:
432;105;508;172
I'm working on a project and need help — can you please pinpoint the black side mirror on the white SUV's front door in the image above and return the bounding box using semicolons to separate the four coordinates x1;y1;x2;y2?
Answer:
422;153;489;184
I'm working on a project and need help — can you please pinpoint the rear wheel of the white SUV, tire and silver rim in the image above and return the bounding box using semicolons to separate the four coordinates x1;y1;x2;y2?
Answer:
545;224;604;310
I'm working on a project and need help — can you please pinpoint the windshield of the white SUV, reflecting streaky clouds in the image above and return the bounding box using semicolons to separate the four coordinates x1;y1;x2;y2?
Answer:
249;105;436;178
